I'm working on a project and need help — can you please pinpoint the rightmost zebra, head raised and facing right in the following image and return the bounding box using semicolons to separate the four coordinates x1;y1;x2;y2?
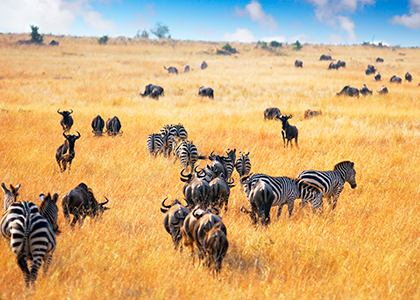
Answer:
298;161;357;210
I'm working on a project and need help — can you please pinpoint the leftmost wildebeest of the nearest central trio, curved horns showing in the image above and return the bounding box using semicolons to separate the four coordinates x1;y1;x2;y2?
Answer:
160;198;190;250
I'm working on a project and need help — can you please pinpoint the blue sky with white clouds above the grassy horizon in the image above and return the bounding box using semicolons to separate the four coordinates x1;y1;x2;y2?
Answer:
0;0;420;47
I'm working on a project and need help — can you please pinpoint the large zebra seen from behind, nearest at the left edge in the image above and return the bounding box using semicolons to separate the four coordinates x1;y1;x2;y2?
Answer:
0;195;58;287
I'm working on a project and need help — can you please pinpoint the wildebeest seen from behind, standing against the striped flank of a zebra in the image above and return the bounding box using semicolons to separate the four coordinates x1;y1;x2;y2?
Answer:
241;179;275;226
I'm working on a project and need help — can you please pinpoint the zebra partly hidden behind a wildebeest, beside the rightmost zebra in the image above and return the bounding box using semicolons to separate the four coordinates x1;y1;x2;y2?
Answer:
240;174;323;218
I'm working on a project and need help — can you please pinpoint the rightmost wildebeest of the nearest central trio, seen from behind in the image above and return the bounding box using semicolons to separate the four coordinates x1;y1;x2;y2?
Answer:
201;222;229;274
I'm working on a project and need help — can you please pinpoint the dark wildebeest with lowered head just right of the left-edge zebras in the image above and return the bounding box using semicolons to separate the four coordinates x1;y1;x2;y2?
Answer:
61;182;109;227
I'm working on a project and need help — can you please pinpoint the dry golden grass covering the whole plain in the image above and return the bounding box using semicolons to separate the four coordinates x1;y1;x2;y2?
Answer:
0;35;420;299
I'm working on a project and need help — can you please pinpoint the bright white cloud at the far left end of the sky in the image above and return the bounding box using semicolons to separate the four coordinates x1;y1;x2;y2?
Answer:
0;0;115;34
